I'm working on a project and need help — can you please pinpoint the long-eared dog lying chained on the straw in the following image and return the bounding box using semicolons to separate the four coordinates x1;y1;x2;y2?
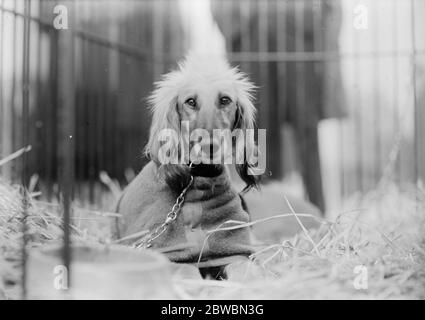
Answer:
116;54;259;278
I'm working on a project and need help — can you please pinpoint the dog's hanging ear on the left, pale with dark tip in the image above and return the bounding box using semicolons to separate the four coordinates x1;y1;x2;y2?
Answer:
145;72;190;192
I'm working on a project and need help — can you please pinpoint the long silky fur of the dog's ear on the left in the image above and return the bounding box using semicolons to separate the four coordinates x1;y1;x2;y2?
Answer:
145;71;190;192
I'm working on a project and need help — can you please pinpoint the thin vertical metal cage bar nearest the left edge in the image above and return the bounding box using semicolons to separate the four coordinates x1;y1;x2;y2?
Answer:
21;0;31;299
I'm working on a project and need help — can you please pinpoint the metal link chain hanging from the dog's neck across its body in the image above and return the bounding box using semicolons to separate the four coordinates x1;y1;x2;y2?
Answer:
134;164;193;249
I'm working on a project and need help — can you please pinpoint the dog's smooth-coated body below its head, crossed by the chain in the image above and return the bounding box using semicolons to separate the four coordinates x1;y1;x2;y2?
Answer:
118;161;252;266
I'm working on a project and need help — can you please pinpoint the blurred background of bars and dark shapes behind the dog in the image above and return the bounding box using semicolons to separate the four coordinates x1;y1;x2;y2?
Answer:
0;0;425;215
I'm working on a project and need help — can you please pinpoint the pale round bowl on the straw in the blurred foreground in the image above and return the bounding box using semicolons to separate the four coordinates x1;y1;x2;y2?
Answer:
28;245;175;299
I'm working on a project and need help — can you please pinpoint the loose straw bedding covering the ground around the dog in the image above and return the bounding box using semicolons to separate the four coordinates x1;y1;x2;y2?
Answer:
0;174;425;299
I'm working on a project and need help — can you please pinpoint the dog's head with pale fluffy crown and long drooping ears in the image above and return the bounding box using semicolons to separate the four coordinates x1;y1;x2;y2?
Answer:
145;55;257;190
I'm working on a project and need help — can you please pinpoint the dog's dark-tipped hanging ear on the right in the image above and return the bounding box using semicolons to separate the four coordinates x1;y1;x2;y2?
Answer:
233;89;260;192
